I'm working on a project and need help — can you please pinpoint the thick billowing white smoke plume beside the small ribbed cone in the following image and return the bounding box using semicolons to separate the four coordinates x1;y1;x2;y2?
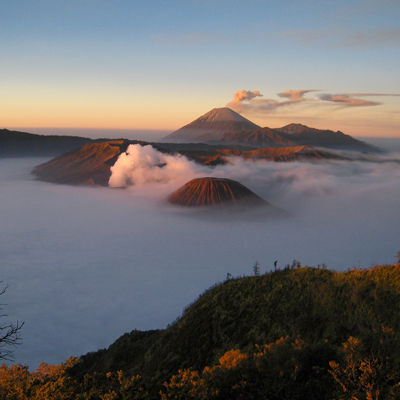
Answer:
108;144;206;187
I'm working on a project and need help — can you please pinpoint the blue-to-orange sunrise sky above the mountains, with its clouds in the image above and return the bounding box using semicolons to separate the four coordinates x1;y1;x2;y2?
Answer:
0;0;400;137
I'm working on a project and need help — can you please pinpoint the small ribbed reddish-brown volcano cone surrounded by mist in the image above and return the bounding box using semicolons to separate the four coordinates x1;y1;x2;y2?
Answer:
167;177;268;207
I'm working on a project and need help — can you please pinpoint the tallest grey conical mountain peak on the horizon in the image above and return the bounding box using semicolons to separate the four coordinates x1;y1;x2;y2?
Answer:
161;107;260;143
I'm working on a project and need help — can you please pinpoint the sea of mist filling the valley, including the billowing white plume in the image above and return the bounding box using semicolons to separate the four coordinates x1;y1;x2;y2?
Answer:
0;143;400;369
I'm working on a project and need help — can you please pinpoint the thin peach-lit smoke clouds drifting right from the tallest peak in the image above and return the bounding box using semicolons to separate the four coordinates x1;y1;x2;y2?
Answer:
226;89;400;113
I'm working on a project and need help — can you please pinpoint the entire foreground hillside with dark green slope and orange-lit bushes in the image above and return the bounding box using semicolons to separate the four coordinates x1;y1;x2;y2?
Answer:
0;262;400;400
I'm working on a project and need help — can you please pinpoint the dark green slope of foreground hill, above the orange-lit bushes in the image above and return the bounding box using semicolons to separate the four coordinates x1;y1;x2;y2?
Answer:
72;263;400;398
